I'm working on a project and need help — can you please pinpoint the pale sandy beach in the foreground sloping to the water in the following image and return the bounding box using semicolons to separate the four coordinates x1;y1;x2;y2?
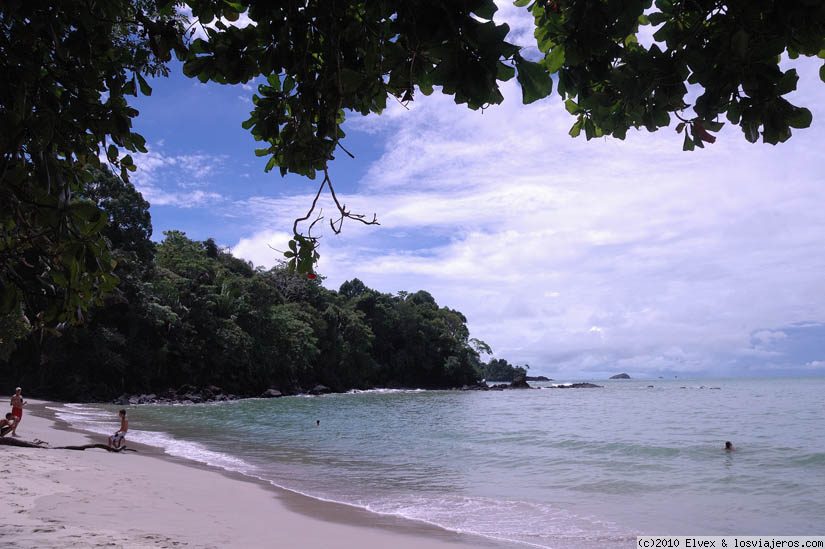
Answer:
0;399;503;549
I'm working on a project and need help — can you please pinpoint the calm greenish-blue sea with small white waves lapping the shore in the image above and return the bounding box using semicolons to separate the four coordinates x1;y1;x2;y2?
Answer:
53;378;825;548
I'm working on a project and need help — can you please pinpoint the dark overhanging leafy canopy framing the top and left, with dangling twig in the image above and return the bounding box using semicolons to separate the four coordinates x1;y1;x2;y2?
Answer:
0;0;825;325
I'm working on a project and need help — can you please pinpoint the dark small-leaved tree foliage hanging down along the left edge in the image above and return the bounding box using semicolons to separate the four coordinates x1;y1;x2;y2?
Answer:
0;0;184;327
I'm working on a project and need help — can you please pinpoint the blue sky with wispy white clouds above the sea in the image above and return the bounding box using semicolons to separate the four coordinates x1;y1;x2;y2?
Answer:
124;2;825;379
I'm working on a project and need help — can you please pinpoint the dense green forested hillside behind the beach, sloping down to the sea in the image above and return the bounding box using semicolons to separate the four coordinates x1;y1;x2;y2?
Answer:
0;169;520;400
